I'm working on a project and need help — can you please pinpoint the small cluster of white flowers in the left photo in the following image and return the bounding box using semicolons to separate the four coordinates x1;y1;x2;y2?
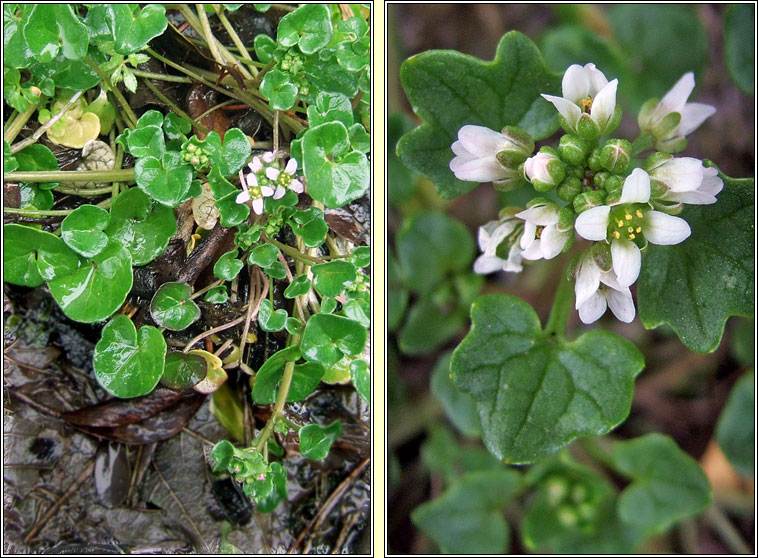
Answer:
236;151;303;215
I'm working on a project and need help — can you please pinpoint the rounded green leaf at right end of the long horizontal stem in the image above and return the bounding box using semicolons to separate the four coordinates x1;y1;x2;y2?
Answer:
134;151;196;207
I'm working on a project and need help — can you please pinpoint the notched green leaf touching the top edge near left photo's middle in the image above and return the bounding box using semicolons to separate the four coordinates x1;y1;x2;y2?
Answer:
108;4;168;54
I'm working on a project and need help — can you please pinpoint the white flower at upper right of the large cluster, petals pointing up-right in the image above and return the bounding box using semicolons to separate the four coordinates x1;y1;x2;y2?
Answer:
638;72;716;153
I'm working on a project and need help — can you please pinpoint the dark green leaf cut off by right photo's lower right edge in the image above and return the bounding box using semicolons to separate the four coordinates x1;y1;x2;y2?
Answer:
716;370;755;477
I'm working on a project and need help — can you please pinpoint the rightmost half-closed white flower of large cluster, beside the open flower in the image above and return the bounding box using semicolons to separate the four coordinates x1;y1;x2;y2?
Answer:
647;156;724;205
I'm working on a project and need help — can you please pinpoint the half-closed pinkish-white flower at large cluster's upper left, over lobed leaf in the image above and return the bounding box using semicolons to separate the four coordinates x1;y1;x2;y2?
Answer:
450;124;534;182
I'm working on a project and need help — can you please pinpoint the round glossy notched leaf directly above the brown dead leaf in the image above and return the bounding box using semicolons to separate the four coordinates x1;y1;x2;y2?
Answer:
92;314;166;399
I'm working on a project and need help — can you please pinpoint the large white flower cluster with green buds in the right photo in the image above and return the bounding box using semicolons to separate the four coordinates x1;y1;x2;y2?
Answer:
450;64;723;323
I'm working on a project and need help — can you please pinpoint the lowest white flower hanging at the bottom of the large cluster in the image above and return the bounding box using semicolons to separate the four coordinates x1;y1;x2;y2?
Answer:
574;253;636;324
